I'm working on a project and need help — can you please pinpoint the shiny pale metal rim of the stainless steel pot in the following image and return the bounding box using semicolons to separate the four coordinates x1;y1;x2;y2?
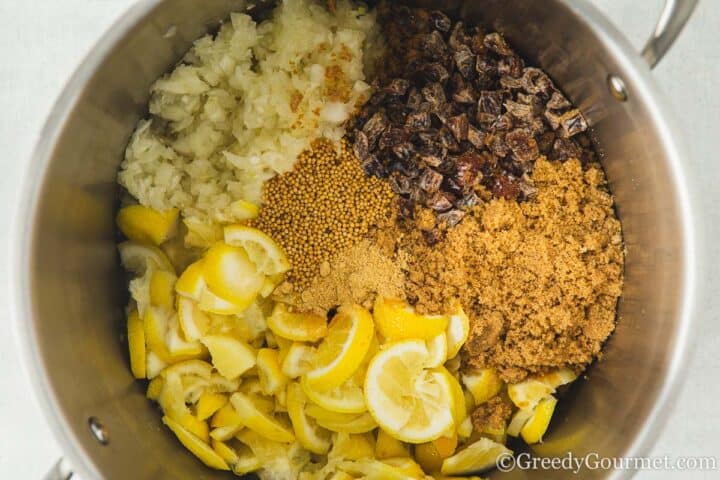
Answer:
11;0;699;480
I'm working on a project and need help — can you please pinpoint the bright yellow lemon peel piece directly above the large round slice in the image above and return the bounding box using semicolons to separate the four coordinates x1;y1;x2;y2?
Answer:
373;297;448;340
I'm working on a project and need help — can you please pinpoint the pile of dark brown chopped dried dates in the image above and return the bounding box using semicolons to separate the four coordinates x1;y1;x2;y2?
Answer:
351;4;592;236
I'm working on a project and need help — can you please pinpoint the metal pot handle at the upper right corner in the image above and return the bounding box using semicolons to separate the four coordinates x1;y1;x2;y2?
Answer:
642;0;698;69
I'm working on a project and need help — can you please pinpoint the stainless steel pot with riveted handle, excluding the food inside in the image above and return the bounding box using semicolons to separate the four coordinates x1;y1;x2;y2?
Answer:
16;0;696;480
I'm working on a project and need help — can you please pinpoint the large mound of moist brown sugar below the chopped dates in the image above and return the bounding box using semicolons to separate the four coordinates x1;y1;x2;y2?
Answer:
400;158;624;383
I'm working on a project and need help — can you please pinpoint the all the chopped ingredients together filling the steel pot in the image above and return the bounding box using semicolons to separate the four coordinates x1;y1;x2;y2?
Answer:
117;0;624;480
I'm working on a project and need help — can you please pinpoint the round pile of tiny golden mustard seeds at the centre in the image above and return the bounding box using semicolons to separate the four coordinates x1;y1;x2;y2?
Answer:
253;141;394;292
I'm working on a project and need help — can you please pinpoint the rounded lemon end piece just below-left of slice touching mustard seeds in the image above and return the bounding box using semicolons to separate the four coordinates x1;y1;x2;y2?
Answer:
203;243;264;309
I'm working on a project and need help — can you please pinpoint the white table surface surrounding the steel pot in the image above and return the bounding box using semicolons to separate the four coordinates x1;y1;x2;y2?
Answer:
0;0;720;480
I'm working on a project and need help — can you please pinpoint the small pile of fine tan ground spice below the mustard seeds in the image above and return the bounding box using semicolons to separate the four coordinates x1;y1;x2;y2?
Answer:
276;239;405;315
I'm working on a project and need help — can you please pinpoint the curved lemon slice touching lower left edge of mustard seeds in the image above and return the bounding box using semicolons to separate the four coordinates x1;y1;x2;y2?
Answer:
225;225;290;276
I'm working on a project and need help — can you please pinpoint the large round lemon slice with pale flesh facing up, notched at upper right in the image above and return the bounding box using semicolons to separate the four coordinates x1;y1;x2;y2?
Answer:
365;340;454;443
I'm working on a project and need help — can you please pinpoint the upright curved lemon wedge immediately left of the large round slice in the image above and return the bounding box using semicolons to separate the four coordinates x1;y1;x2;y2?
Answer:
306;305;375;390
